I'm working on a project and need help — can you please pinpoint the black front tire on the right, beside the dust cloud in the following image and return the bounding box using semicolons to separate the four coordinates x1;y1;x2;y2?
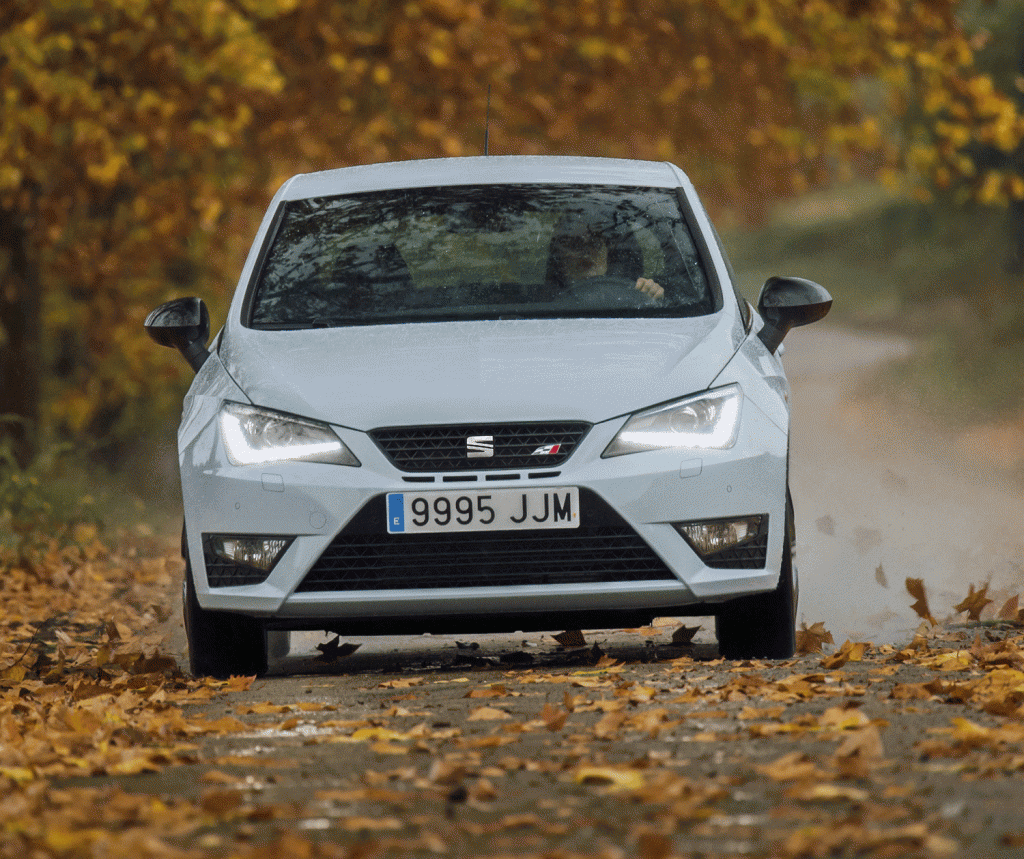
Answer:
715;493;798;659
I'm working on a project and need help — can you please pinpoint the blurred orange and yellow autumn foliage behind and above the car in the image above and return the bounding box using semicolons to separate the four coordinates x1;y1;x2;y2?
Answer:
0;0;1024;461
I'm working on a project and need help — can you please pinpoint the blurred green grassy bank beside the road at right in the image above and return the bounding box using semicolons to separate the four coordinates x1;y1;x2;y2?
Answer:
723;186;1024;430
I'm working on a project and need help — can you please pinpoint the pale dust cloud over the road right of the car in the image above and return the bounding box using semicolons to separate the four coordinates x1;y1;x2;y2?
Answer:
783;327;1024;644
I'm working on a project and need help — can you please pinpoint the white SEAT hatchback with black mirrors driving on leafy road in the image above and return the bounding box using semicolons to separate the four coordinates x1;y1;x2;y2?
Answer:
145;157;831;676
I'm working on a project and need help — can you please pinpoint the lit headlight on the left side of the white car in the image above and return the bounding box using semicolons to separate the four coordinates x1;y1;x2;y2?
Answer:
220;402;359;466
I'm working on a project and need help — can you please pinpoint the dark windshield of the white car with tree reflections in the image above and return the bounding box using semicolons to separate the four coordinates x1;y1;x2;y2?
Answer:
249;185;717;328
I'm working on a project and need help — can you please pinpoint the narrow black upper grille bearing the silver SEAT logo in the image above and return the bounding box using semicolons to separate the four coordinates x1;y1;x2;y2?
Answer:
370;421;591;471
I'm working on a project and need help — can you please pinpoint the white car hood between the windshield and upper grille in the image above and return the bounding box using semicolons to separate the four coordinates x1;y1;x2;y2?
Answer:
219;313;741;430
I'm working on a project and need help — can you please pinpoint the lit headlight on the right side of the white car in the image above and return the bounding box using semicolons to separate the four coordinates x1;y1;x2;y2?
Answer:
601;385;743;457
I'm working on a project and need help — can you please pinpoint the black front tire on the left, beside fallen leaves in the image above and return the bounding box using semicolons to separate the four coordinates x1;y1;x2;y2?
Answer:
182;559;267;679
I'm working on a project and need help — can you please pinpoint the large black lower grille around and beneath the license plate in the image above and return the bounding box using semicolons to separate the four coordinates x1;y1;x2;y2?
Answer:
298;489;676;591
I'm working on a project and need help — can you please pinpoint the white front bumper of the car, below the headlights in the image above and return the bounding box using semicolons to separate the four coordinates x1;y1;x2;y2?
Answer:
181;398;787;633
